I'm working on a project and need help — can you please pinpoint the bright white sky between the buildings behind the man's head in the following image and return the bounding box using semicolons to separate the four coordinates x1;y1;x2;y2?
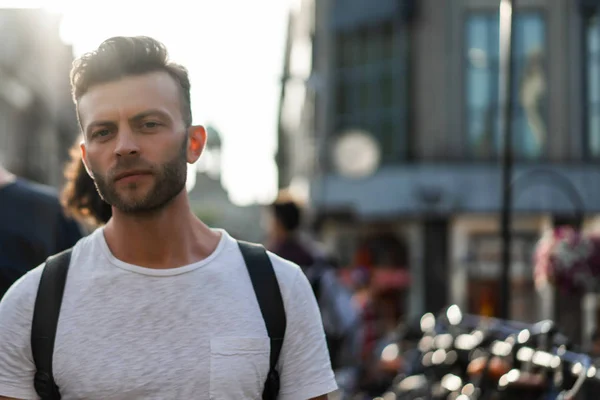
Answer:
0;0;292;205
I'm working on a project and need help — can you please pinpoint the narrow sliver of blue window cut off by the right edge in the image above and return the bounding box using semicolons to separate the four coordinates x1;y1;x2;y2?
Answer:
585;15;600;158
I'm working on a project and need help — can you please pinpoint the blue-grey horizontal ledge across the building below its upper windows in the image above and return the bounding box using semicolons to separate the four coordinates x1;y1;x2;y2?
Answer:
311;164;600;218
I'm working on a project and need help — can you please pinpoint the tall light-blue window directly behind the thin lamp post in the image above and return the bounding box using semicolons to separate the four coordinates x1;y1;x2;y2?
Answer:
464;12;548;159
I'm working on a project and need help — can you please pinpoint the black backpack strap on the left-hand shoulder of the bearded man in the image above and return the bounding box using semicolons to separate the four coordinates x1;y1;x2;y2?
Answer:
31;249;71;400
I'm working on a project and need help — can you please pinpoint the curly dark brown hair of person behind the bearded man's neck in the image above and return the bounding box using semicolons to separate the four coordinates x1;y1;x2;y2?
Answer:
60;139;112;226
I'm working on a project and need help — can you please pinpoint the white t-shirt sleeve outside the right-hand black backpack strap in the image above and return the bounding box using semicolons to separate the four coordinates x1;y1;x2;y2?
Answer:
279;269;337;400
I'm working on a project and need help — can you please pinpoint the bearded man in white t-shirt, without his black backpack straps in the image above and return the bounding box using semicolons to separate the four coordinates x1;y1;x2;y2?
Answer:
0;37;336;400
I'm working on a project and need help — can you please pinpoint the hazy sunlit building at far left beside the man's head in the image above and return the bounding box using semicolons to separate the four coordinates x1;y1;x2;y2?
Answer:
0;9;78;187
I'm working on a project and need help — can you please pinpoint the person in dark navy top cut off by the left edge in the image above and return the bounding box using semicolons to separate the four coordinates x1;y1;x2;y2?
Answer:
0;166;82;298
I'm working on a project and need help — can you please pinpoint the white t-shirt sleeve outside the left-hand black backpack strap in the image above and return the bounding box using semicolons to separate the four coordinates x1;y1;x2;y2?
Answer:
0;268;41;400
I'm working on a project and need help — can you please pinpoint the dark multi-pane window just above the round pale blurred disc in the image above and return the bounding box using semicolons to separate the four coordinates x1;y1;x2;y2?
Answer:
334;22;406;163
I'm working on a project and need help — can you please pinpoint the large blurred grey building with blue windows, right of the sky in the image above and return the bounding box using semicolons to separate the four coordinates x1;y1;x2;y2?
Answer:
278;0;600;338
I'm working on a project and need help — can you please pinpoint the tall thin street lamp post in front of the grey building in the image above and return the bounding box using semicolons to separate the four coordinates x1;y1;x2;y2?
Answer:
498;0;515;319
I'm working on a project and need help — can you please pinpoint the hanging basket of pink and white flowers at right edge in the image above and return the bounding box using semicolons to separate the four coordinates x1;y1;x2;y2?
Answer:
534;227;600;294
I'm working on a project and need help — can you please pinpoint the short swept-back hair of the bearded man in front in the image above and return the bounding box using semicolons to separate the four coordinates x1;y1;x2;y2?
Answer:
71;36;192;127
